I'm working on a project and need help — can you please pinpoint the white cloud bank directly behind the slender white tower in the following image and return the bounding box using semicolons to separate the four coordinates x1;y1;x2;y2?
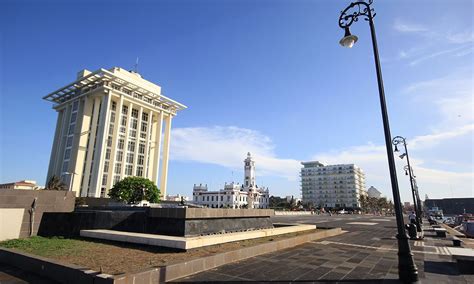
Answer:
170;126;301;181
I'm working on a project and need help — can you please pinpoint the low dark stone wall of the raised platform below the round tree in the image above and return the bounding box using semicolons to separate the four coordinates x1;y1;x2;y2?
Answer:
38;206;273;237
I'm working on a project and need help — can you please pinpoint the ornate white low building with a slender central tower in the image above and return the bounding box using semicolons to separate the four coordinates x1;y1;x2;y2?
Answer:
193;153;270;209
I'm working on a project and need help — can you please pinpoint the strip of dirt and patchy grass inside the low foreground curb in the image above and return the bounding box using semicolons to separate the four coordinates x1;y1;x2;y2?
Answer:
0;230;321;274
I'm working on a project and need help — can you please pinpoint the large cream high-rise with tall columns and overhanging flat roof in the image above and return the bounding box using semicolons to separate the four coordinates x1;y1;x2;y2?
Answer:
44;67;186;197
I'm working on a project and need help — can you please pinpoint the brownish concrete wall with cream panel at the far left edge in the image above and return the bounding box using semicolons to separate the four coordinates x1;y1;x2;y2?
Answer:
0;189;75;241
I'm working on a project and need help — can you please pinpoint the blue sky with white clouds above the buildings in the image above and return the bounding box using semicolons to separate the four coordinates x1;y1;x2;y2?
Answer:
0;0;474;200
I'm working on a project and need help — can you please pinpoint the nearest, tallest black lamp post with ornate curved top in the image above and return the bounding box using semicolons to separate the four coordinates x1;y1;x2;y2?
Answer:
339;0;418;282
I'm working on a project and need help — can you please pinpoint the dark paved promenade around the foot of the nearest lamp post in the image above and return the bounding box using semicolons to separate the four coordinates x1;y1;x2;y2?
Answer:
177;215;474;283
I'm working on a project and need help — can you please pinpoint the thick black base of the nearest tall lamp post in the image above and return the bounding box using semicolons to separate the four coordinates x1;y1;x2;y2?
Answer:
397;234;418;283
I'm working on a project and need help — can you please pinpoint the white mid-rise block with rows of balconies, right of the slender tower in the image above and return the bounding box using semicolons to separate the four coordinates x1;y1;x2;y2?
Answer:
301;161;367;208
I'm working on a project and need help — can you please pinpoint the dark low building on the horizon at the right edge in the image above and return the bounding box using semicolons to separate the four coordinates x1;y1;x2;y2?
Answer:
425;197;474;215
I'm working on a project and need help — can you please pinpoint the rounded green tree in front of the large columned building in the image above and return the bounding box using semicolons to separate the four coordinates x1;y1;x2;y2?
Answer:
109;177;160;204
